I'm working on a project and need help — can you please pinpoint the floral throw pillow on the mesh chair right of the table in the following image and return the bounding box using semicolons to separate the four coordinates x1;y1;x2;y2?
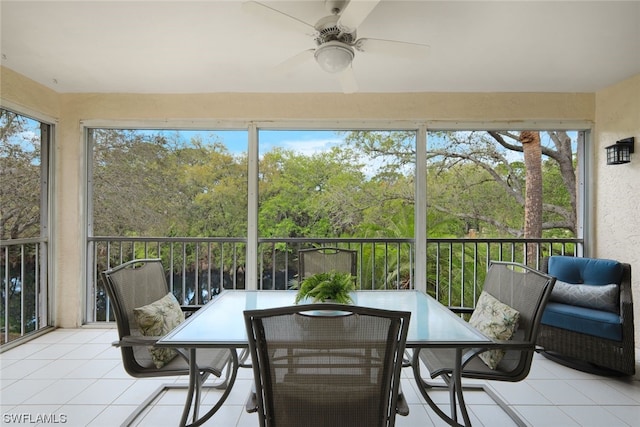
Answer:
469;291;520;369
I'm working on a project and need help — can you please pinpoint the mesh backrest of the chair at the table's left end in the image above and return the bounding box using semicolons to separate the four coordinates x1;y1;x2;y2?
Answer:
102;259;169;376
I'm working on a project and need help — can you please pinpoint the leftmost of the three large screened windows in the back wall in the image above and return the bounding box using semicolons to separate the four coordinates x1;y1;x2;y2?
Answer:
87;128;248;321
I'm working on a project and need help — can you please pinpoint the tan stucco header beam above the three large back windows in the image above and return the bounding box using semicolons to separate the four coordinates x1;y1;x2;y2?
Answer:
61;93;595;121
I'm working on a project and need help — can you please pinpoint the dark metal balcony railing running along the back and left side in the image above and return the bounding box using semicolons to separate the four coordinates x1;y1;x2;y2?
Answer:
0;237;583;344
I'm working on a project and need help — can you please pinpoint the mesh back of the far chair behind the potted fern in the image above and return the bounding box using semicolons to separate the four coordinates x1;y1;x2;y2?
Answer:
298;248;358;280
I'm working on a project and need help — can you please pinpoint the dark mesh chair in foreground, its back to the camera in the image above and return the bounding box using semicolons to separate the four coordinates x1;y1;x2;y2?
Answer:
245;304;411;427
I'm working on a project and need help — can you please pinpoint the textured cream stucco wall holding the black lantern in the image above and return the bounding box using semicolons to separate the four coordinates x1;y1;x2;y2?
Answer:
592;74;640;362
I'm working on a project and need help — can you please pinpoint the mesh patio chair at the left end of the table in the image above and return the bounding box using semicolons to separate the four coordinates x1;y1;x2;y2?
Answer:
102;259;230;424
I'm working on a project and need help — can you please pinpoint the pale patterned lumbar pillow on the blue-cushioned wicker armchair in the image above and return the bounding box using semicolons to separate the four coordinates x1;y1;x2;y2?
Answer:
549;280;620;313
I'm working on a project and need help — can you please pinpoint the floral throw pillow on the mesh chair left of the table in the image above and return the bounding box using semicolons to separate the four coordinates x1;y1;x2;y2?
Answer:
133;292;184;369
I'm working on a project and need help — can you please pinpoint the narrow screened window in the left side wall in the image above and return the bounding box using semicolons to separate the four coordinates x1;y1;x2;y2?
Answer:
0;109;51;344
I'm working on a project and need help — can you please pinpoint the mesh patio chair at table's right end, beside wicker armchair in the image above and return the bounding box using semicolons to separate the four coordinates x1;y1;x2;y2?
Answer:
412;261;556;425
